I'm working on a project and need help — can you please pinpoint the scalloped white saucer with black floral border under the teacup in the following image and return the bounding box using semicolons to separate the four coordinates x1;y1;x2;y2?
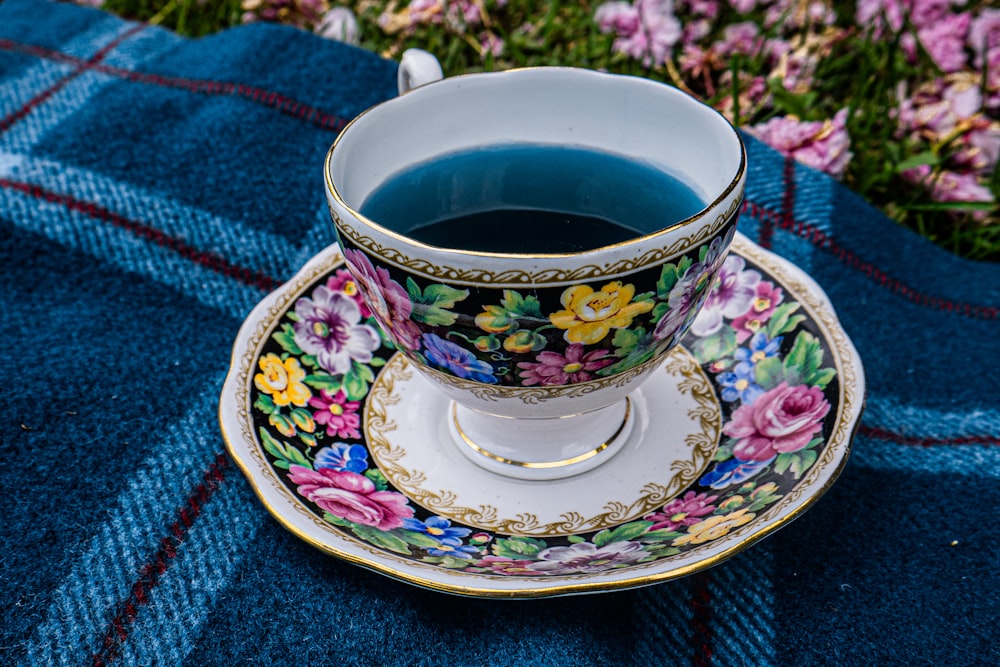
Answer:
219;234;864;598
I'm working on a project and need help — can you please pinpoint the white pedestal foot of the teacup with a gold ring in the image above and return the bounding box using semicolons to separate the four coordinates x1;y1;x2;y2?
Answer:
449;398;636;480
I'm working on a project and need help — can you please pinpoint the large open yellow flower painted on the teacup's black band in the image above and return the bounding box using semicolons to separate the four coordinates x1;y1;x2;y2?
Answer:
549;280;653;345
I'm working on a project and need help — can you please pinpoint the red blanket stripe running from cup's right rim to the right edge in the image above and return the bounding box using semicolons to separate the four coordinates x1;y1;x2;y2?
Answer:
743;200;1000;320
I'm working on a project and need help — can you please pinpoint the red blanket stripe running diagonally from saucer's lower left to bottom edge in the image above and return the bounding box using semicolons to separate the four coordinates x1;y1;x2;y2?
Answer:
92;452;229;667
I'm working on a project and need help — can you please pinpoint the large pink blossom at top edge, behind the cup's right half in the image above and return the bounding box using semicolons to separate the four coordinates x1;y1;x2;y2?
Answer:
594;0;681;67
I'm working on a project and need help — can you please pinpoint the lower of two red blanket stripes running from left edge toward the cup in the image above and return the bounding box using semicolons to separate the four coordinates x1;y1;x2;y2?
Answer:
0;178;280;292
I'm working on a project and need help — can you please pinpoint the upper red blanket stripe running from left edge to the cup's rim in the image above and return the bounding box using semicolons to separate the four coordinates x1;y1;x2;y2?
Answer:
0;39;347;132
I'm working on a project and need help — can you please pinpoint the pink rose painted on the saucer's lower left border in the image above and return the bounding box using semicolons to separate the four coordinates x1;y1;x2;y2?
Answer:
288;465;413;530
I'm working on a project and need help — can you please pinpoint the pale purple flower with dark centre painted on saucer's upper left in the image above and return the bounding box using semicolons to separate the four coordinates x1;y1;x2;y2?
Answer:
293;285;382;375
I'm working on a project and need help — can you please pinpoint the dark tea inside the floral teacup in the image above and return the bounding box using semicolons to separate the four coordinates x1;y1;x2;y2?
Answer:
360;144;705;254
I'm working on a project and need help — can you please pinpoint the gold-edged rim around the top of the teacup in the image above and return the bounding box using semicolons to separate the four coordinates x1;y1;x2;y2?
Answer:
323;65;747;261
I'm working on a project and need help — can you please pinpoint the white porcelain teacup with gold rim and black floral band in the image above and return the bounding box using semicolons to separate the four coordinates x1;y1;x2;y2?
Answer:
325;54;746;480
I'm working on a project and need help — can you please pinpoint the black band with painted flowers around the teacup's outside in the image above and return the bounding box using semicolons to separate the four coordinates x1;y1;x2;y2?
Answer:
340;225;735;387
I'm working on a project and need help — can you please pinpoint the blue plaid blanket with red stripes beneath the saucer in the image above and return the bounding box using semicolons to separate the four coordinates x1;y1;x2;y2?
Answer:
0;0;1000;665
